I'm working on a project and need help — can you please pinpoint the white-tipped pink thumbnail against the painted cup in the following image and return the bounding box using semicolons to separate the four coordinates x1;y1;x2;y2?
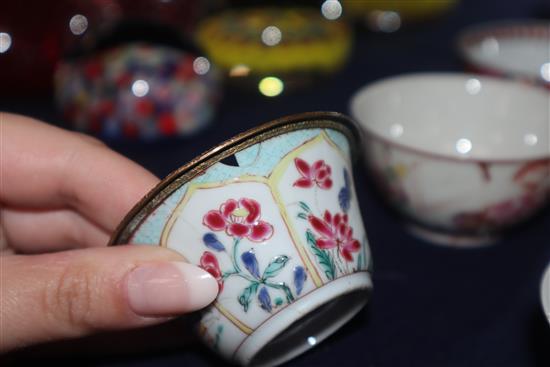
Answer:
127;262;218;316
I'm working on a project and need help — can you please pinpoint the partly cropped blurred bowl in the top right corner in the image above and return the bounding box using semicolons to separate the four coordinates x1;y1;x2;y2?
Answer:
458;20;550;89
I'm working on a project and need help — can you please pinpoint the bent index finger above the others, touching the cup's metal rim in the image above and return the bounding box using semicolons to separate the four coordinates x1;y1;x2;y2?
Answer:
0;112;158;232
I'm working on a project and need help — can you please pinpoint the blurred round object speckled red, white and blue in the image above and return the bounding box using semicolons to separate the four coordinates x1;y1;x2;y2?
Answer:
55;42;221;140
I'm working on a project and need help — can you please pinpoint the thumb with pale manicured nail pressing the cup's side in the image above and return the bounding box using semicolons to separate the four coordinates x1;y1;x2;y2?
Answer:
0;246;218;352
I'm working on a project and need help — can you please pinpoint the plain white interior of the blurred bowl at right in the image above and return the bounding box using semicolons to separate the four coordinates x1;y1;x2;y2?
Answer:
352;73;550;160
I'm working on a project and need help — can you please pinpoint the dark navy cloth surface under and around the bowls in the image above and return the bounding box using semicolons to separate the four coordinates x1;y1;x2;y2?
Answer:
0;0;550;367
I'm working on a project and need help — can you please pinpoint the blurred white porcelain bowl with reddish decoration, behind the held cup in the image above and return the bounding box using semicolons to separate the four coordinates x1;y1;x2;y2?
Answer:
351;73;550;246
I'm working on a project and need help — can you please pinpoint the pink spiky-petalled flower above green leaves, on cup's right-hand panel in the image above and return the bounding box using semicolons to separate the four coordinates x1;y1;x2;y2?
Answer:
308;210;361;261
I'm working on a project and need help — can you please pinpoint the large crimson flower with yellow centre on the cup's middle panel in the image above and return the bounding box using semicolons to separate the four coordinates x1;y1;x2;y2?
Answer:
202;198;273;242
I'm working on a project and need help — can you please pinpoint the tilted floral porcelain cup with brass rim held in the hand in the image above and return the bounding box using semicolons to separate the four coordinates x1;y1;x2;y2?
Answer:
111;112;371;365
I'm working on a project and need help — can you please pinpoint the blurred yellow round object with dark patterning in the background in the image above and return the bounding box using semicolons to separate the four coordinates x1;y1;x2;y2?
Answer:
197;4;352;93
